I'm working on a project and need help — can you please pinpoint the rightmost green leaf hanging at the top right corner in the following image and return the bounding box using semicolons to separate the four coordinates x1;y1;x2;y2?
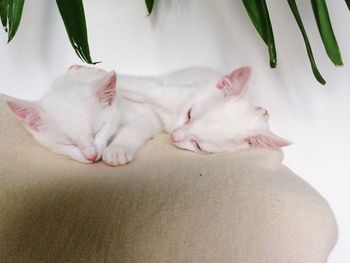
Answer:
311;0;343;66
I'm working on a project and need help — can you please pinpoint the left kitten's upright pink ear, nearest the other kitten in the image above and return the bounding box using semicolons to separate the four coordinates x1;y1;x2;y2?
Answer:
93;71;117;105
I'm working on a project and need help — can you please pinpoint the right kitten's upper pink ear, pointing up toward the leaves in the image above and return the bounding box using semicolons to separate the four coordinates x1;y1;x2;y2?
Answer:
216;67;252;99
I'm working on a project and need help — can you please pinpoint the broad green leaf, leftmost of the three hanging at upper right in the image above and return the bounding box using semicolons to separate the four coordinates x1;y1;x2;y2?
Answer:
242;0;277;68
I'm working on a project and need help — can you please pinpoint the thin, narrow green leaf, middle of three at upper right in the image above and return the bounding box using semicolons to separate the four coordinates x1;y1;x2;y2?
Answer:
287;0;326;85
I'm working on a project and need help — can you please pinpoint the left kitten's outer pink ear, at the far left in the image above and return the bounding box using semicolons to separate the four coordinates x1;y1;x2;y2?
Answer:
6;100;42;131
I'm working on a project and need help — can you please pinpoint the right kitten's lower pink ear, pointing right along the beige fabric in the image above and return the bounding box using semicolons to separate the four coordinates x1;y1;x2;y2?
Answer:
244;132;291;148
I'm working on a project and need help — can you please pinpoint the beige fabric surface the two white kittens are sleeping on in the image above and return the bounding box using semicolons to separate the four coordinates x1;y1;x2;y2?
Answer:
0;99;337;263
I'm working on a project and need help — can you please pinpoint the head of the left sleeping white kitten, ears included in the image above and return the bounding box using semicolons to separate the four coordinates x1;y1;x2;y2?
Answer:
7;67;119;163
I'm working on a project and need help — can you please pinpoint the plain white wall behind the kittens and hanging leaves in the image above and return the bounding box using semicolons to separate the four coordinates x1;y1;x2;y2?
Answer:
0;0;350;263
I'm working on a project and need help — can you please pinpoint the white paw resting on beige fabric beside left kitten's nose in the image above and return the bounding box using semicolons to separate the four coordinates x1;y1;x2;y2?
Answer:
102;145;135;166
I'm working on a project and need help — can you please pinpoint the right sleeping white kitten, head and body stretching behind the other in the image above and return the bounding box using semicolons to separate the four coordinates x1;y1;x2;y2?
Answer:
118;67;290;157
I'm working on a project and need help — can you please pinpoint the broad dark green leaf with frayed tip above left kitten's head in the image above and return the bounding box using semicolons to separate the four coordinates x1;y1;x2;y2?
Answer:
56;0;97;64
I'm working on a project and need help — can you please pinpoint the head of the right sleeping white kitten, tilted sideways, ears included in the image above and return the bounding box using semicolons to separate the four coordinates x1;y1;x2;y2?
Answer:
170;67;290;153
